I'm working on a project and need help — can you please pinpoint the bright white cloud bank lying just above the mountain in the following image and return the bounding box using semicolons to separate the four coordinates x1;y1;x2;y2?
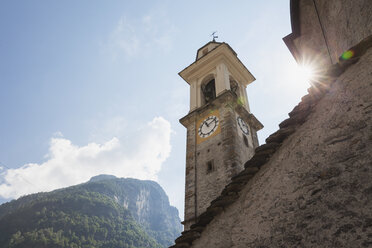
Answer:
0;117;172;198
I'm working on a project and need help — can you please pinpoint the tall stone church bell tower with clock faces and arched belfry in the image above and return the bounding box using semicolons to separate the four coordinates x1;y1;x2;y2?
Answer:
179;41;263;230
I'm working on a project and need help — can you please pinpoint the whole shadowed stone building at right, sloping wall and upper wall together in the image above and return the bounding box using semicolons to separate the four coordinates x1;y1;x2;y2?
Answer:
173;0;372;248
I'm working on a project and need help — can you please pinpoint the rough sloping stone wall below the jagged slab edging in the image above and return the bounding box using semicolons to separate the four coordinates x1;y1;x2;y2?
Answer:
192;48;372;248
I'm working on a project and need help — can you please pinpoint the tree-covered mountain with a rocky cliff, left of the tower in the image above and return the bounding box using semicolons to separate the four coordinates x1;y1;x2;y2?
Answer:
0;175;182;248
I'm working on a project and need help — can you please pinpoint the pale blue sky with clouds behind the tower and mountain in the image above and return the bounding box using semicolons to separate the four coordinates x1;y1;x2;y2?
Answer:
0;0;309;218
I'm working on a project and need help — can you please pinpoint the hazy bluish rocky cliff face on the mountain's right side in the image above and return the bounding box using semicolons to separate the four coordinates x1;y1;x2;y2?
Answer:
85;175;182;245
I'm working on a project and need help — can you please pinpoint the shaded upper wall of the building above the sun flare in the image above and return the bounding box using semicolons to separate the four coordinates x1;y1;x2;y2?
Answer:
292;0;372;65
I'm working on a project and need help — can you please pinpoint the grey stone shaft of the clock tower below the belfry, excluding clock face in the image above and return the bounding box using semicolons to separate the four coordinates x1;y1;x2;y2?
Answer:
184;92;257;230
